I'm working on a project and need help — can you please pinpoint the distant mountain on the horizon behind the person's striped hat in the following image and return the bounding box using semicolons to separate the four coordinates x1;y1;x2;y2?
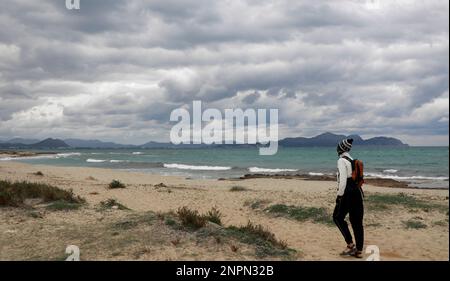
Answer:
279;133;408;147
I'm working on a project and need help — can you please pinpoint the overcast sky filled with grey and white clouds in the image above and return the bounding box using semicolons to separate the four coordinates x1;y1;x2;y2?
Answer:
0;0;449;145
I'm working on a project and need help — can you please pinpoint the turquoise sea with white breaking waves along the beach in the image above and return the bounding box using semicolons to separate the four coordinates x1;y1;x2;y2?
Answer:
1;147;449;188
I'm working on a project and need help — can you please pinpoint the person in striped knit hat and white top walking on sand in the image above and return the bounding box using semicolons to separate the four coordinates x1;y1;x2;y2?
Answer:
333;139;364;258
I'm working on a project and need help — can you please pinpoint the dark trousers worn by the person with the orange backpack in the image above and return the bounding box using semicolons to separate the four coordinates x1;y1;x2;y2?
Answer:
333;183;364;251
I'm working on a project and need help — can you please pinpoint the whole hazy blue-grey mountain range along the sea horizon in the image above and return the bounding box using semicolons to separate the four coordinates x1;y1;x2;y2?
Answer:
0;132;408;149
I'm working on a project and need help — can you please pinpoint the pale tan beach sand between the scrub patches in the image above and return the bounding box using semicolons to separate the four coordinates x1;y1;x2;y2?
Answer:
0;161;449;260
